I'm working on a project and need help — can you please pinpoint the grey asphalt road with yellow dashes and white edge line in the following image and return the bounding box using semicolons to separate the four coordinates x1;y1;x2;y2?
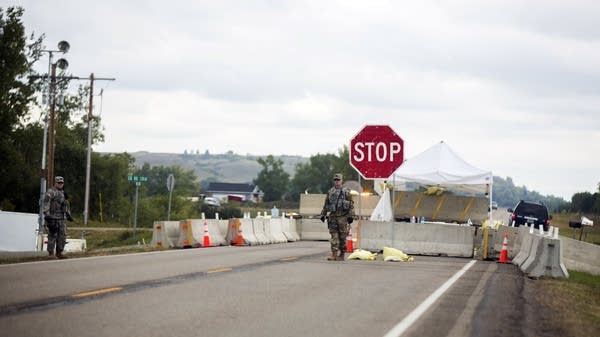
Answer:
0;241;539;337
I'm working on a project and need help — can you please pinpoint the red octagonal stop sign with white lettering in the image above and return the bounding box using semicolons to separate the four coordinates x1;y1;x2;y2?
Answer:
350;125;404;179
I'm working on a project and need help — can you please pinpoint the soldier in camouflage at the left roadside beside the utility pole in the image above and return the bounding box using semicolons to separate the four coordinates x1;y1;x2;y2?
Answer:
44;176;72;259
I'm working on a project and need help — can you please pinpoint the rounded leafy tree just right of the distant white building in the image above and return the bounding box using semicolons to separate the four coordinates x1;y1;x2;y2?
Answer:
254;155;290;201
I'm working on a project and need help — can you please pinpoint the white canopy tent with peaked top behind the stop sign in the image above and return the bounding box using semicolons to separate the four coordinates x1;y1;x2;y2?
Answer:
388;141;493;226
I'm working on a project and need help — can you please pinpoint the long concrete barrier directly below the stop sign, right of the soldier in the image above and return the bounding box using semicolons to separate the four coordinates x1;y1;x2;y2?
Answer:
359;221;475;257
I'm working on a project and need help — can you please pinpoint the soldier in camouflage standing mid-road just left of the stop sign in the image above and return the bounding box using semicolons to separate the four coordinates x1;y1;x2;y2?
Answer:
321;173;354;261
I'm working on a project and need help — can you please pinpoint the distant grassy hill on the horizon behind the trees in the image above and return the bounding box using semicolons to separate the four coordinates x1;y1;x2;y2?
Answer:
129;151;309;187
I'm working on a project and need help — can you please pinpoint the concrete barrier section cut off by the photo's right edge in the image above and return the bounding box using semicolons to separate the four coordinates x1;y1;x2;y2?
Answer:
561;237;600;275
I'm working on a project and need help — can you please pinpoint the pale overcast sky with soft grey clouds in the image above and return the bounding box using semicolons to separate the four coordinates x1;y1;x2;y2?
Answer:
9;0;600;200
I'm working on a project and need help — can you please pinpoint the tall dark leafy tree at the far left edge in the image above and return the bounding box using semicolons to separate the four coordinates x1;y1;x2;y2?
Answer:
0;7;41;210
